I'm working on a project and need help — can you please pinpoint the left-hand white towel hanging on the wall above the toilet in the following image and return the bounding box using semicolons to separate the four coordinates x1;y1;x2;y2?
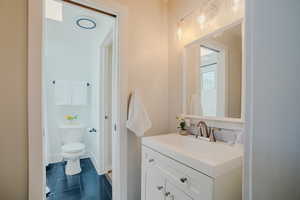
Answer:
55;81;72;106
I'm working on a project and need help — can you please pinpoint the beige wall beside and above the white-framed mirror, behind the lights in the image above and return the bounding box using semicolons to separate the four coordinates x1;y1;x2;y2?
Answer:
168;0;244;131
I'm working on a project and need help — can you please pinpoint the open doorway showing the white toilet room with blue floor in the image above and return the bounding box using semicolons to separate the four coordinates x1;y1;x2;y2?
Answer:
42;0;118;200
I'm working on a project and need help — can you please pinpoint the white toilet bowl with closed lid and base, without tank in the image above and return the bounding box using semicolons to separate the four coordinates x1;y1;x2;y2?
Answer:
61;142;85;175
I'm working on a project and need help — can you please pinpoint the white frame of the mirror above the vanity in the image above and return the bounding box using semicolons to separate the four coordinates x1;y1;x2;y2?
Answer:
182;18;246;129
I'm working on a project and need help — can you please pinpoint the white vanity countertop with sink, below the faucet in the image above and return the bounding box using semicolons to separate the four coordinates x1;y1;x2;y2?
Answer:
142;134;243;178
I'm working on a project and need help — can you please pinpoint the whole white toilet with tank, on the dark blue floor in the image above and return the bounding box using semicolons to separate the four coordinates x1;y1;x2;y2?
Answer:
60;125;85;175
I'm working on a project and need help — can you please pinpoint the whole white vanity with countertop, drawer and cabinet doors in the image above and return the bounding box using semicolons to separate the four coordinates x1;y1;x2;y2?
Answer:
142;134;243;200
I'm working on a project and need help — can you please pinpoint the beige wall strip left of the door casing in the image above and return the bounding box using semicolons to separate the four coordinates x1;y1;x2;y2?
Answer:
0;0;27;200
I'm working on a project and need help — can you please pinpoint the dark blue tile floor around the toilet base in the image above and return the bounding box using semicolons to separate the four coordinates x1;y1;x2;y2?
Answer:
46;158;112;200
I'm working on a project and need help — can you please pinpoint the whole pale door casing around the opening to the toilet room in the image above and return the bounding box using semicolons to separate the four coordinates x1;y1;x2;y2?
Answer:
27;0;128;200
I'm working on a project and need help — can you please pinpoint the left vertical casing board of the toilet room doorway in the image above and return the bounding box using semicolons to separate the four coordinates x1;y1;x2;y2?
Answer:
28;0;45;200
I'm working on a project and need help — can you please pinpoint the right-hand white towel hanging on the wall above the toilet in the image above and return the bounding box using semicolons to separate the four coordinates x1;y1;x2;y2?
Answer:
72;81;88;106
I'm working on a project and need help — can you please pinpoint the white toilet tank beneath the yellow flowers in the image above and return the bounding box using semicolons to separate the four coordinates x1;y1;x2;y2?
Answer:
59;124;85;144
